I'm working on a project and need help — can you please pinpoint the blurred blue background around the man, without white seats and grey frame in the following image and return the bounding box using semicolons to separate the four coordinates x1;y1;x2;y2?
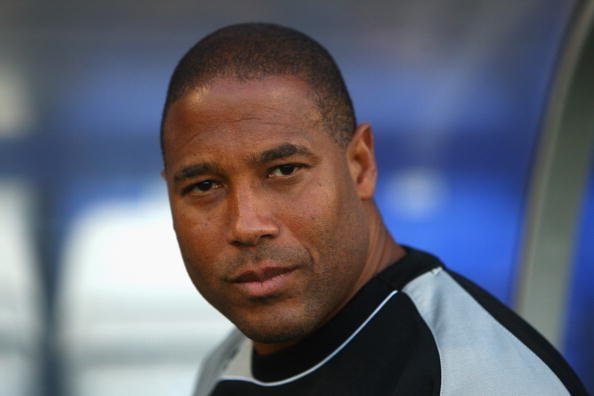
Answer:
0;1;594;391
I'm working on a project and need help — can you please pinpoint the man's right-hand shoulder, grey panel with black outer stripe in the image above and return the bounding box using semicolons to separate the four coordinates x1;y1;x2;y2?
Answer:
402;252;585;395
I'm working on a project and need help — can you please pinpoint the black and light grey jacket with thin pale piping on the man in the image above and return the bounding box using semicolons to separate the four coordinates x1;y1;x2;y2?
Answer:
195;249;586;396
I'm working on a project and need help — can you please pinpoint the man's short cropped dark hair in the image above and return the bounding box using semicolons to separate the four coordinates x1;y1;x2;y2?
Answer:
161;23;356;156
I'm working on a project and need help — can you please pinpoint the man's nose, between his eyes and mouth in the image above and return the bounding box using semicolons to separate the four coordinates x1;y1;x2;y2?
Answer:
228;186;280;246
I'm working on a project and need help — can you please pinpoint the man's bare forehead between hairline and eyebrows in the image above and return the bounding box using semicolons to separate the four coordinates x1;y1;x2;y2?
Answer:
164;76;328;166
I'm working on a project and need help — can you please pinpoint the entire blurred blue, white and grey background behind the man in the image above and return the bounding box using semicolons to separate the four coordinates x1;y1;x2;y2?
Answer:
0;0;594;396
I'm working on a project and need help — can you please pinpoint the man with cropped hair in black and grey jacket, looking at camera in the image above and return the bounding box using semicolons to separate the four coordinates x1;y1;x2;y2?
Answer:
161;24;585;395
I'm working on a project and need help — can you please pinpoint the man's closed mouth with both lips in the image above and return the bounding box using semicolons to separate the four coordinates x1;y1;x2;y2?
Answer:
231;266;297;298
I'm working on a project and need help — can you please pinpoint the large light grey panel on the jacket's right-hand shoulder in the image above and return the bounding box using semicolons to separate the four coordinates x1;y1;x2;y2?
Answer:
403;268;569;396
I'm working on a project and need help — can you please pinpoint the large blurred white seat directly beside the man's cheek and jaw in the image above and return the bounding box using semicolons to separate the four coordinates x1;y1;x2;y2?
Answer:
58;186;230;396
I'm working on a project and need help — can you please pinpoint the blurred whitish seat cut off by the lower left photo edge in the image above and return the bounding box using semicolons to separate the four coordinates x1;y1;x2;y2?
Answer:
0;181;41;396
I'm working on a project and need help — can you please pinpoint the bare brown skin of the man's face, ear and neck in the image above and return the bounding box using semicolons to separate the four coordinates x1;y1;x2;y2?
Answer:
163;76;404;354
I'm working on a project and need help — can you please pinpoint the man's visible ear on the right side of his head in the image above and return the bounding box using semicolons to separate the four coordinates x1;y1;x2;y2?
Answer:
346;124;377;200
